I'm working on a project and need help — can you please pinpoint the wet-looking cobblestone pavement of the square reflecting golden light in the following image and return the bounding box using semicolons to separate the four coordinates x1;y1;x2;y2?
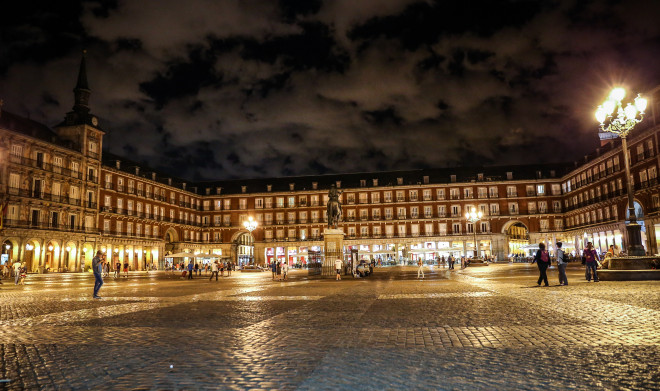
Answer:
0;264;660;390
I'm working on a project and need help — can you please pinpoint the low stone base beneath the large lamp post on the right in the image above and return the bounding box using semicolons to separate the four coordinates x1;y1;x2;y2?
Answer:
597;256;660;281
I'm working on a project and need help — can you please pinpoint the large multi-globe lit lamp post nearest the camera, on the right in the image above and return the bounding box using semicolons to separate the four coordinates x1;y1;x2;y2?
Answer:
596;87;647;256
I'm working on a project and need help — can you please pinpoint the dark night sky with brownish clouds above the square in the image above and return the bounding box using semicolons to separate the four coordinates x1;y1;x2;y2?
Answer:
0;0;660;180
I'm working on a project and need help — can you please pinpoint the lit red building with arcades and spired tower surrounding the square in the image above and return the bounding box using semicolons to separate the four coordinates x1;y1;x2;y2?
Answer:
0;63;660;272
